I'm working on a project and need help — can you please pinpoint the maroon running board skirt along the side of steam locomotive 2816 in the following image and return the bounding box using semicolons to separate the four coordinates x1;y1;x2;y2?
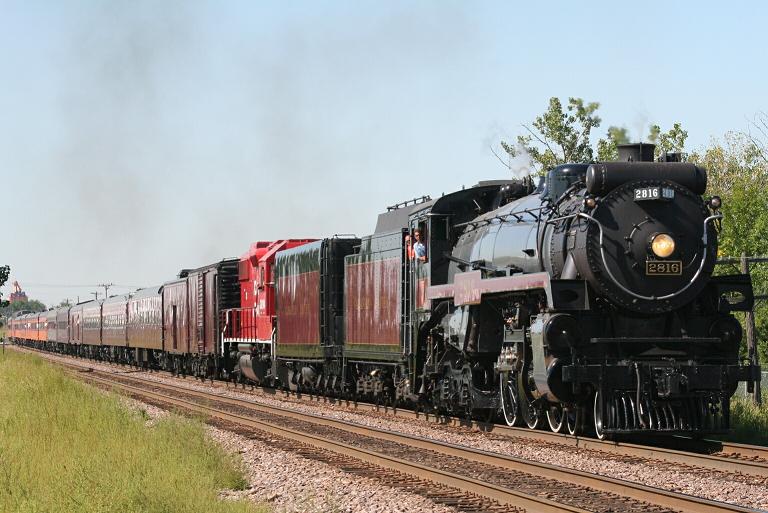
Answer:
426;271;589;310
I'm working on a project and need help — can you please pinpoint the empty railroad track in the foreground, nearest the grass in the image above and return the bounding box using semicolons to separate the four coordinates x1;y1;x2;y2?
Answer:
36;354;755;512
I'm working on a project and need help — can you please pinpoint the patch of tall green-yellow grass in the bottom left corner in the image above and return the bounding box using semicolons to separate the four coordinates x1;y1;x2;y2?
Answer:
0;350;265;513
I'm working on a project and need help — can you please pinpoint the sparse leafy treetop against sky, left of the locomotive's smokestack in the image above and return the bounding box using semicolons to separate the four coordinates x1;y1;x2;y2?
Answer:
501;97;601;173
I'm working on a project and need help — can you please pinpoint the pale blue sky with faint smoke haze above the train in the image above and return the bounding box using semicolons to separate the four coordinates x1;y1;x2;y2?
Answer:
0;0;768;303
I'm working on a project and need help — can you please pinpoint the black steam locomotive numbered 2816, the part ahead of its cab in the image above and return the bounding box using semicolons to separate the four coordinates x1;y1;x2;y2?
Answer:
421;144;759;438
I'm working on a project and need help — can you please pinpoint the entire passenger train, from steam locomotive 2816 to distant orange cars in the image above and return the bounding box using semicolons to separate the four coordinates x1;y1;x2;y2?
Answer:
10;144;760;438
